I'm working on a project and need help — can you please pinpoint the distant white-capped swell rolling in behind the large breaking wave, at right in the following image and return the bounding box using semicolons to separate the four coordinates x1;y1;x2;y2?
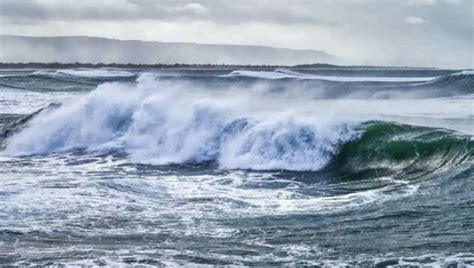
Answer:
220;69;474;98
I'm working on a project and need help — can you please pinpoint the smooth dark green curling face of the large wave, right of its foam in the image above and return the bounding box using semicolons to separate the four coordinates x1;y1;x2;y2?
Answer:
328;122;474;179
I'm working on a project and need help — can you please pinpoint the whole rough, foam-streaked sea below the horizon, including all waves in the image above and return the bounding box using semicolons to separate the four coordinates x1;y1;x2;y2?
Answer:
0;67;474;266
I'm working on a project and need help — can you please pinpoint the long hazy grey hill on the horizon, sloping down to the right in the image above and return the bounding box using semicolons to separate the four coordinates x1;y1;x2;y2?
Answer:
0;35;336;65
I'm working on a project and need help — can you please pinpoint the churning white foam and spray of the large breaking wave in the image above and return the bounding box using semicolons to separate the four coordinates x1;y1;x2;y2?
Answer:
1;74;360;170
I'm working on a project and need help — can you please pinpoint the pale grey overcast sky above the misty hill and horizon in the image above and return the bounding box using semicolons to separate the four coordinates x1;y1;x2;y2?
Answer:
0;0;474;68
